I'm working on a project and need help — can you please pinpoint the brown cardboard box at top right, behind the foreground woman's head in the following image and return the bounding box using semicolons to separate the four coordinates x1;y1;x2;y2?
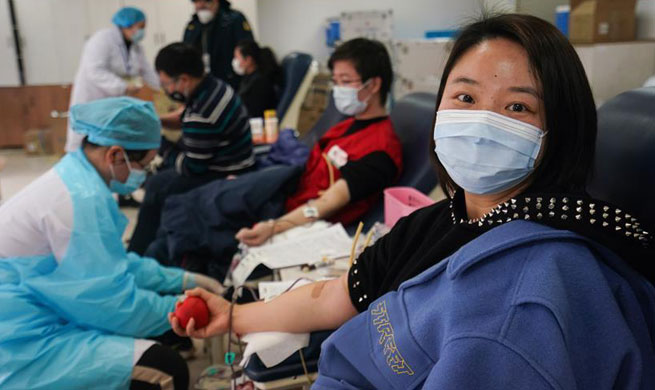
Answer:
569;0;637;43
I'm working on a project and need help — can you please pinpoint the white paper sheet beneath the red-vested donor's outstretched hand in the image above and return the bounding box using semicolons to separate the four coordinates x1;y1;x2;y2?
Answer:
250;224;352;269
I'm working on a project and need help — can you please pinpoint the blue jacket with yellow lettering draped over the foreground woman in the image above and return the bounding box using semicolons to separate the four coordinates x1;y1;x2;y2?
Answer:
312;221;655;390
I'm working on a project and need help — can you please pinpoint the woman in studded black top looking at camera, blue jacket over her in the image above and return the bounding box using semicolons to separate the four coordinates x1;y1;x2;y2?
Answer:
171;14;655;390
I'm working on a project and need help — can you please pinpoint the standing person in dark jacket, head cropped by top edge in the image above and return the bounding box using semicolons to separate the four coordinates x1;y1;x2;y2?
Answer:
183;0;253;90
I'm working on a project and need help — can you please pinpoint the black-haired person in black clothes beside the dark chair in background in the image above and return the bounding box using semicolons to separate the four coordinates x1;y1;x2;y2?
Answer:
232;39;281;118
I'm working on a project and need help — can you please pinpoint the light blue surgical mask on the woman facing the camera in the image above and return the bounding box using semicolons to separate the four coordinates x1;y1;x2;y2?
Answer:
434;110;545;194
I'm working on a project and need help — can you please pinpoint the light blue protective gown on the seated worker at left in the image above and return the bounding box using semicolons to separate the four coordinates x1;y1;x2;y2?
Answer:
0;150;184;390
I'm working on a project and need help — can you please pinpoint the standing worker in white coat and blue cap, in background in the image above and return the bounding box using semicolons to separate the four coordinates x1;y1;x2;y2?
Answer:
66;7;159;152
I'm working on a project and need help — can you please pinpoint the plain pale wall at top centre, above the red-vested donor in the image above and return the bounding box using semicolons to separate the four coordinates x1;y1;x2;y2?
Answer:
256;0;481;61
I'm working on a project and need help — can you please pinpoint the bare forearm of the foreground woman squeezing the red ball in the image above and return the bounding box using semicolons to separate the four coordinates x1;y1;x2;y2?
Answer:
233;278;357;334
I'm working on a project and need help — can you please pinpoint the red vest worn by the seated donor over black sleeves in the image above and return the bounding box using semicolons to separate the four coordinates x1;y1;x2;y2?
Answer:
286;118;403;225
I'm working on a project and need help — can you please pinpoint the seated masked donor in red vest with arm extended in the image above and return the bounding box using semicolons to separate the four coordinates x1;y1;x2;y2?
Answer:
236;38;402;246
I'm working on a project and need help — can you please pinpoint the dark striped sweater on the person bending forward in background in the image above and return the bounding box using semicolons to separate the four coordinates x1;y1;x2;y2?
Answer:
175;76;255;176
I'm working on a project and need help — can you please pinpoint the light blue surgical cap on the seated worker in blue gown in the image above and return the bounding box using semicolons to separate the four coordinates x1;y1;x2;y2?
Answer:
70;96;161;150
